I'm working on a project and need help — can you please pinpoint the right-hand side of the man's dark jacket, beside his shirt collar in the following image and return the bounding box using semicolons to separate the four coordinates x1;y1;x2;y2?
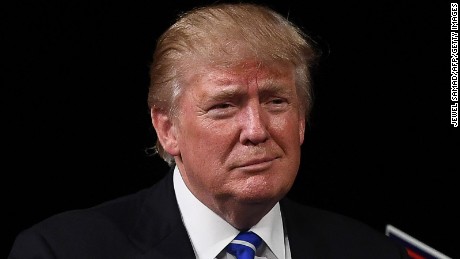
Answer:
281;199;408;259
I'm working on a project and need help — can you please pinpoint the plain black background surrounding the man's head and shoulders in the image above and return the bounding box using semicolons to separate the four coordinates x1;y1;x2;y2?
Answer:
0;0;459;258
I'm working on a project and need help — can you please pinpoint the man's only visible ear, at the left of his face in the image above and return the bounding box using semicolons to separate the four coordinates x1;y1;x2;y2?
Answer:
150;108;180;156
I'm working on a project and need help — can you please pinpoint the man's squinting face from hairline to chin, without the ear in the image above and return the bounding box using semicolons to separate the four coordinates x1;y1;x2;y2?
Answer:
174;60;305;213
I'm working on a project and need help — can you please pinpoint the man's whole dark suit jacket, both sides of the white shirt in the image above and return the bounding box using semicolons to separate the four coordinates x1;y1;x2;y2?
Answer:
8;172;407;259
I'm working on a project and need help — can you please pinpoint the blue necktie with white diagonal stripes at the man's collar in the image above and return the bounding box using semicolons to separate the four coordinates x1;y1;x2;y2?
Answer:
227;231;262;259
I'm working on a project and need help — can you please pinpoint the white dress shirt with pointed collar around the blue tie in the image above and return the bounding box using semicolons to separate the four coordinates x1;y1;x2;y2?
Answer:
174;166;291;259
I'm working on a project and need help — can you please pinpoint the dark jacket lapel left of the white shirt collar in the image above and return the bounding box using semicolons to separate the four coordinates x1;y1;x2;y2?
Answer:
129;169;195;258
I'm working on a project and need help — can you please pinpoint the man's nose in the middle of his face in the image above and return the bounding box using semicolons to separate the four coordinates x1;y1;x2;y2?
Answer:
240;102;270;145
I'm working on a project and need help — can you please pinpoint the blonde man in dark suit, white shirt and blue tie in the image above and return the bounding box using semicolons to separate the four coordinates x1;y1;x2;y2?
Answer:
9;4;407;259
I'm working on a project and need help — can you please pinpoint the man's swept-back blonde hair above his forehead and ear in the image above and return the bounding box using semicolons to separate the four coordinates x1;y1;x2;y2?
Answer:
148;3;316;165
